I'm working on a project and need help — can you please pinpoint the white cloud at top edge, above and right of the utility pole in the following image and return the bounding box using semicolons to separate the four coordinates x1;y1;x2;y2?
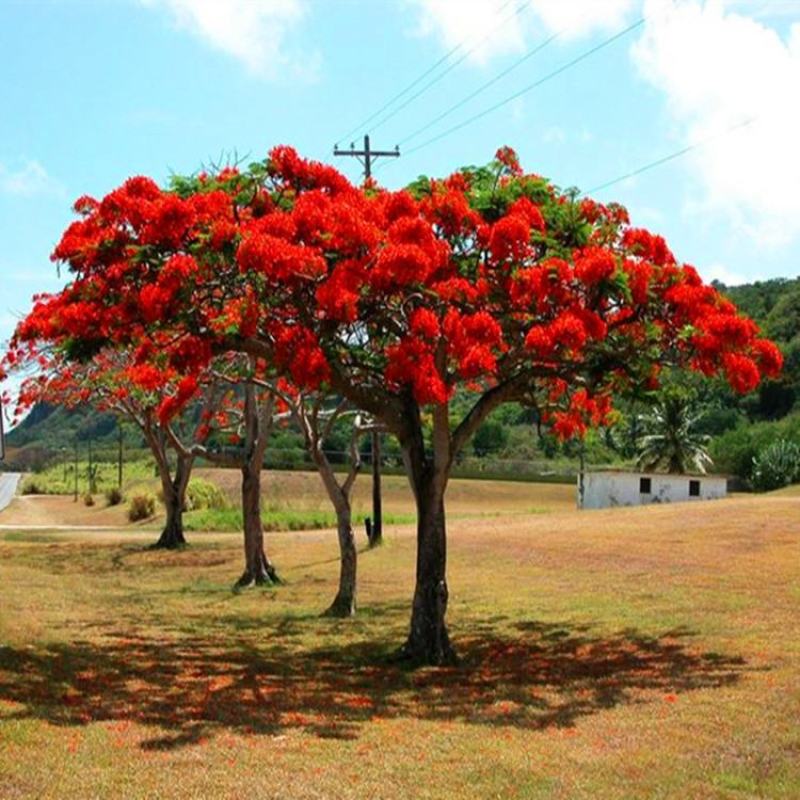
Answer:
406;0;637;63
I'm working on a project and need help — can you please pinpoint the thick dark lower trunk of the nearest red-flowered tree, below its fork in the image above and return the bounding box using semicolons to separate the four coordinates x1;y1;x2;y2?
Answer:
400;486;456;666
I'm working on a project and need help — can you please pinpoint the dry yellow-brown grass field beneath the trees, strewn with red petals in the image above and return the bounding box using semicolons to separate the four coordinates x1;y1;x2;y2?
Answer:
0;483;800;800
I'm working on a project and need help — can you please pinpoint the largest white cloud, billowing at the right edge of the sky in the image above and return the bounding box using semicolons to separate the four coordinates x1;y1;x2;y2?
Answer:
632;0;800;245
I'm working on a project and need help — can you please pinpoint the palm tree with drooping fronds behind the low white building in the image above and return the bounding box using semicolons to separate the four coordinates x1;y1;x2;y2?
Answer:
637;394;713;475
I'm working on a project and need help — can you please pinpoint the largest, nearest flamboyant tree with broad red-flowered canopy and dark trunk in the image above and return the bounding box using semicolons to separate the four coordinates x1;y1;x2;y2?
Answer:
17;147;781;663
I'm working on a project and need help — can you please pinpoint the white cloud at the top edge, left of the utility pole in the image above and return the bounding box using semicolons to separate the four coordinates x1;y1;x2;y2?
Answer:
139;0;319;79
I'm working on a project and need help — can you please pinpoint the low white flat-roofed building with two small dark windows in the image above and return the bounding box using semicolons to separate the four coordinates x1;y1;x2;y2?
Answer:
577;470;728;508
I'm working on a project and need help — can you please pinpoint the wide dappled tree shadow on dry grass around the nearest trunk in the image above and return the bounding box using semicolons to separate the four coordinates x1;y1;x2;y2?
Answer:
0;619;750;750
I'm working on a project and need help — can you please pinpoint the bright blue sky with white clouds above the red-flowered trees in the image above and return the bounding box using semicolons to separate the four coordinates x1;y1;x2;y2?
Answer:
0;0;800;350
